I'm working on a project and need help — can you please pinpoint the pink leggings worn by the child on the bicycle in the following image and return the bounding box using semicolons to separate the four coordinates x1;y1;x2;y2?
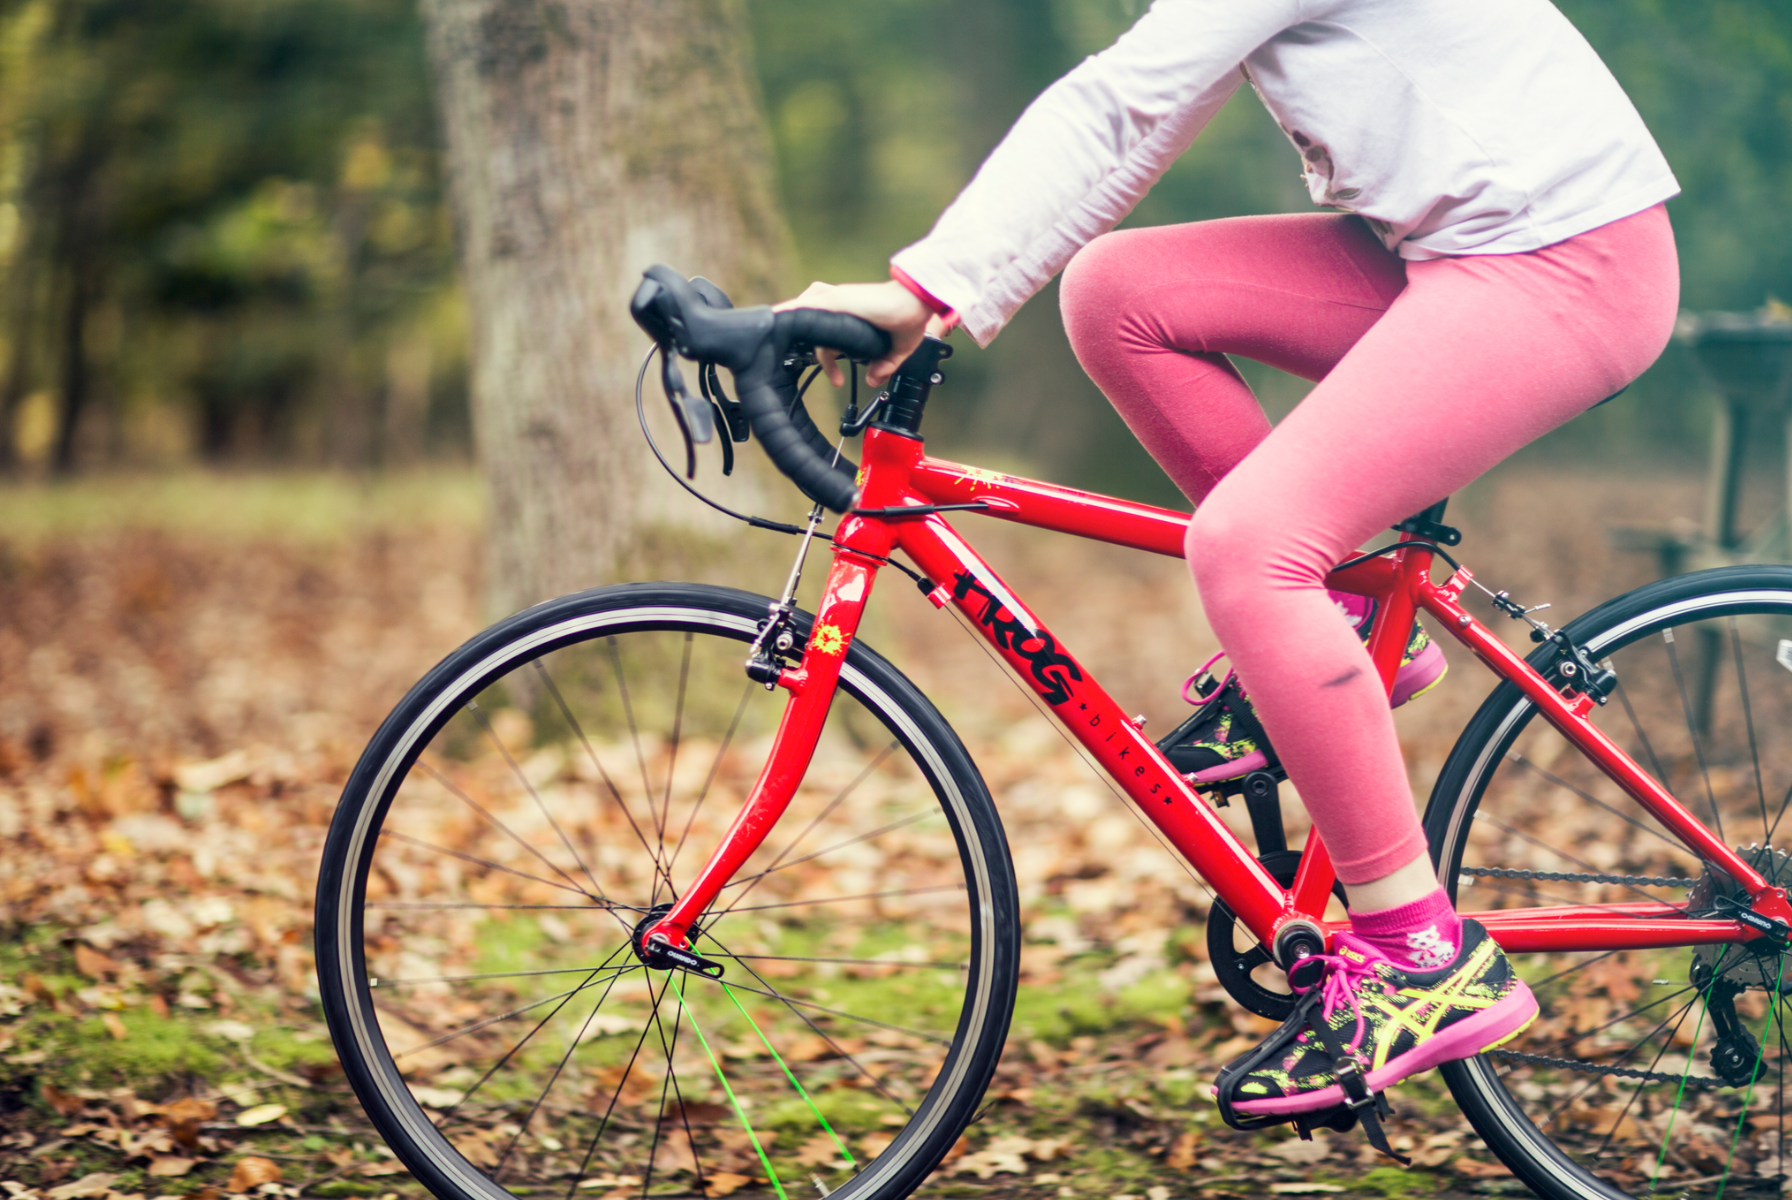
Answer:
1063;206;1679;885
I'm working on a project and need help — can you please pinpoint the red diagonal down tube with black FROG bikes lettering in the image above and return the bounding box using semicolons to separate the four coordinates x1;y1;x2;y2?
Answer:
898;516;1290;942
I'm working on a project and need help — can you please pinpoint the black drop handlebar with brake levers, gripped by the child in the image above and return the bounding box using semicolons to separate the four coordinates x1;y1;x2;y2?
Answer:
629;263;891;512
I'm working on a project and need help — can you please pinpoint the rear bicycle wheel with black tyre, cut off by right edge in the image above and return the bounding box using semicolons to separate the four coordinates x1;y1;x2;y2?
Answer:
1425;566;1792;1200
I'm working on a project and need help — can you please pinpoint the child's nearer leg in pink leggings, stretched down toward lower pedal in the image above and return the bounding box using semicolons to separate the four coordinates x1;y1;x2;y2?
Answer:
1188;208;1677;891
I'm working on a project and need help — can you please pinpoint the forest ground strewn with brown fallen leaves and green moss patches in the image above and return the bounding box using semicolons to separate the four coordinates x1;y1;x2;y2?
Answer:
0;467;1720;1200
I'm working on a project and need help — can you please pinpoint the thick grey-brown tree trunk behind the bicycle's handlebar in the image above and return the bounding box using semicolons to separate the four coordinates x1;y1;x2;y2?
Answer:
423;0;788;613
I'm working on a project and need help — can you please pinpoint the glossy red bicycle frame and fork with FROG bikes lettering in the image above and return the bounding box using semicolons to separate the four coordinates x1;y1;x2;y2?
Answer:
647;428;1792;953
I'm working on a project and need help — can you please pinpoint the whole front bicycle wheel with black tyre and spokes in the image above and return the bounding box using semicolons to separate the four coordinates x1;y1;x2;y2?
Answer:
317;584;1020;1200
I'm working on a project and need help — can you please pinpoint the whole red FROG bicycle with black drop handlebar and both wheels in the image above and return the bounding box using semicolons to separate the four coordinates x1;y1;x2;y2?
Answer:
317;267;1792;1200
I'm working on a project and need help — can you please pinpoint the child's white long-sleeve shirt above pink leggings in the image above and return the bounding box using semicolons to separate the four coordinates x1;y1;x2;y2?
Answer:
891;0;1679;346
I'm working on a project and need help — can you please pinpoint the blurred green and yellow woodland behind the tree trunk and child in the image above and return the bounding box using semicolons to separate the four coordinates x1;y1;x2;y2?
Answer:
0;0;1792;501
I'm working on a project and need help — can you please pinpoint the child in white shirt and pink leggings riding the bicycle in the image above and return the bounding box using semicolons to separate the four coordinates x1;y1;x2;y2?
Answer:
785;0;1679;1139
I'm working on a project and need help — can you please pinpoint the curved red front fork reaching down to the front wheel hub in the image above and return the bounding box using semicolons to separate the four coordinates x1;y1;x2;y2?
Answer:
636;548;878;967
